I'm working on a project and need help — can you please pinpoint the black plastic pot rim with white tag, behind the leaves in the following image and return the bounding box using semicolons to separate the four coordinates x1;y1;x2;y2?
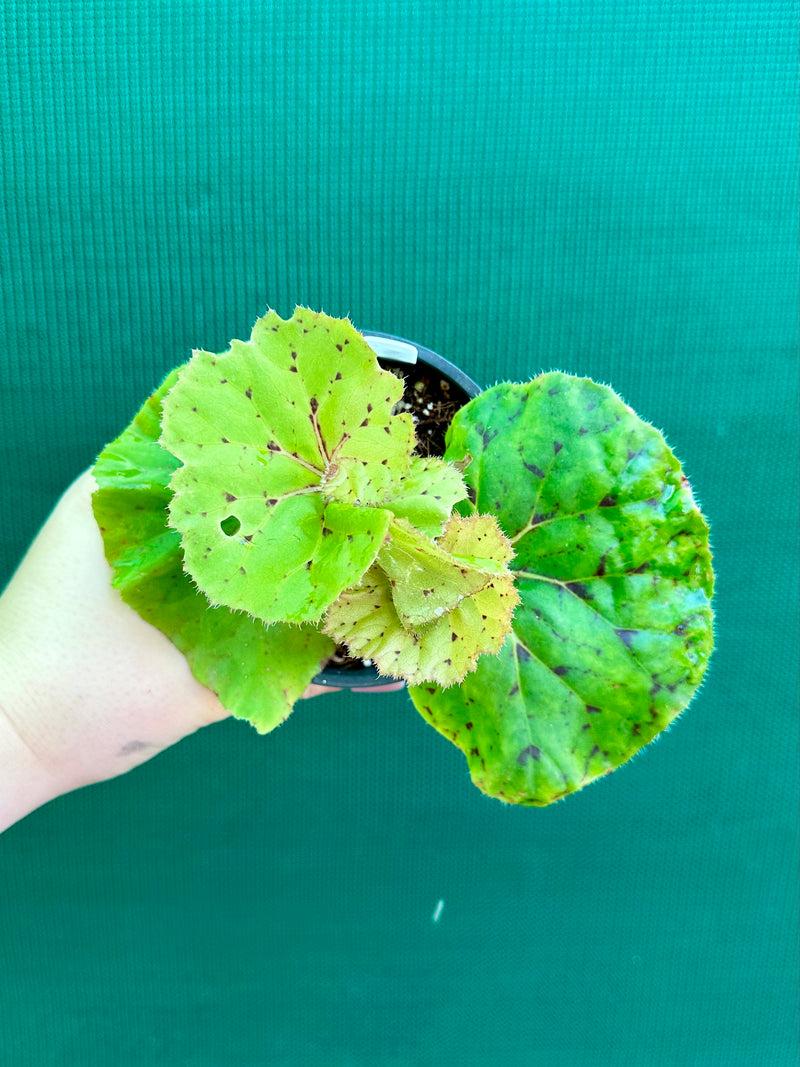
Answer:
314;330;481;689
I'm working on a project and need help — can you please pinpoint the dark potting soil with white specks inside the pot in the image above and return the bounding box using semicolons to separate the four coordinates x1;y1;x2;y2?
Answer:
326;360;469;670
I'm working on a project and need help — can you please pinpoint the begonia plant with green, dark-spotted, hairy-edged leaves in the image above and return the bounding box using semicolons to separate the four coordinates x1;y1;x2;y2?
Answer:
93;307;714;806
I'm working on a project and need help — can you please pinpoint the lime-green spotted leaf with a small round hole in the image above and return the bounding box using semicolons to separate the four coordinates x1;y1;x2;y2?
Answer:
161;307;414;622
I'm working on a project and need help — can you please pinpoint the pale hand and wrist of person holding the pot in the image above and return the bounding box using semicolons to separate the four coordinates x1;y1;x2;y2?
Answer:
0;472;402;832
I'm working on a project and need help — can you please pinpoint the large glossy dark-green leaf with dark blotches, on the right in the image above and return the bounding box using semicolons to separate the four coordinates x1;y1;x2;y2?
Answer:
410;372;714;805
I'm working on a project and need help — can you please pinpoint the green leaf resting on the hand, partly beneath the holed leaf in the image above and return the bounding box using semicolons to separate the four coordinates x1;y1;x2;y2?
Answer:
92;368;334;733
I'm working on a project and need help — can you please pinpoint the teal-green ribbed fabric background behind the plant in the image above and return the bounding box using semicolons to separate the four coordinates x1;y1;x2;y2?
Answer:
0;0;798;1067
